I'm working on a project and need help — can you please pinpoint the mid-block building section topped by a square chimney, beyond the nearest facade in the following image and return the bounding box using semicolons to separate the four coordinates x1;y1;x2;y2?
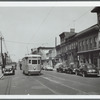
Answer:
56;29;77;64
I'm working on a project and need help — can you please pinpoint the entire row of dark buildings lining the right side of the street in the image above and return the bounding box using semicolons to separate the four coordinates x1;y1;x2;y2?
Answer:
56;7;100;69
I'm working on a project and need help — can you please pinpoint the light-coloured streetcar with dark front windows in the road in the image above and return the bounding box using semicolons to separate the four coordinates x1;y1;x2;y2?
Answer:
22;54;41;75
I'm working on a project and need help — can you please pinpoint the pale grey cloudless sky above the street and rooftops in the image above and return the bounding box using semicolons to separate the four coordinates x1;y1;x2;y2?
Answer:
0;2;97;61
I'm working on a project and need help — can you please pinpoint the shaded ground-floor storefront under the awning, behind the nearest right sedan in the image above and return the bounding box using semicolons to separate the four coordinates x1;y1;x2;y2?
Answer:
77;49;100;69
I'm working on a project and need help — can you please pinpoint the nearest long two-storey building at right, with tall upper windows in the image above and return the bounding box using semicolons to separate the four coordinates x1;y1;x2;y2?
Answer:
77;25;100;67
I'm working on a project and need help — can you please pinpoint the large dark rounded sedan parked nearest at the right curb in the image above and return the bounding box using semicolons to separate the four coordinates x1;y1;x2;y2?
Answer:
75;63;99;77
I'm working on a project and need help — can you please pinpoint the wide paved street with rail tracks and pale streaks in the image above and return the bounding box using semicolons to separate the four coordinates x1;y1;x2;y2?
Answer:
0;68;100;95
